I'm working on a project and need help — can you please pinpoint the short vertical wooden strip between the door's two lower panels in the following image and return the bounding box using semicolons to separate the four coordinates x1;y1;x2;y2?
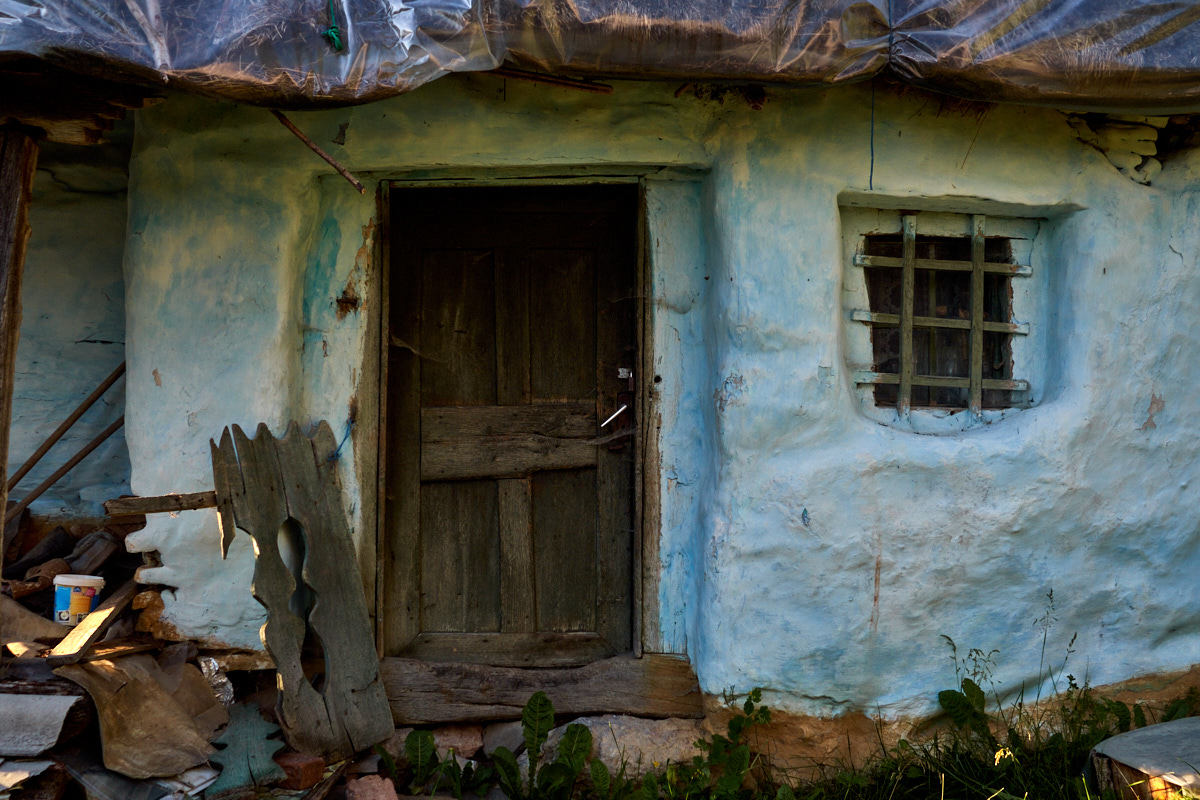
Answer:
497;477;536;633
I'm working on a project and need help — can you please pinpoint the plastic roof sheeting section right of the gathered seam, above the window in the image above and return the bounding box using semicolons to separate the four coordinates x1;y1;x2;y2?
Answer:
888;0;1200;114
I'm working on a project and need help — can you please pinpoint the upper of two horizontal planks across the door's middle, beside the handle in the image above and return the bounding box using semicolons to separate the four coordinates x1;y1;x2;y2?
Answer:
421;402;596;444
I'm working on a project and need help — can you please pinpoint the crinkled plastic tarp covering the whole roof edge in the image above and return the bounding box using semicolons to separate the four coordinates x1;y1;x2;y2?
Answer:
0;0;1200;113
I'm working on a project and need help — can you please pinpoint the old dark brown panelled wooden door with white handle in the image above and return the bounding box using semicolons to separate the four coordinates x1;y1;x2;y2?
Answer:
382;186;637;667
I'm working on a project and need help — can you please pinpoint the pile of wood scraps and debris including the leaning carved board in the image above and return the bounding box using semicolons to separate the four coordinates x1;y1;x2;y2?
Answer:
0;423;395;800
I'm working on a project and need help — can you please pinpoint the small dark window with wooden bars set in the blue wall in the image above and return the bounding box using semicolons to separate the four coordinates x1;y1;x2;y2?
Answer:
851;213;1032;415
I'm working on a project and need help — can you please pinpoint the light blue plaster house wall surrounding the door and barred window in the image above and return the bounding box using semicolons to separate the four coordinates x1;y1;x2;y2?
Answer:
125;76;1200;716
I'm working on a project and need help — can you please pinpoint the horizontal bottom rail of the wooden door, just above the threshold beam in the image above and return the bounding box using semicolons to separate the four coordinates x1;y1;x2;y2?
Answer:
401;632;617;668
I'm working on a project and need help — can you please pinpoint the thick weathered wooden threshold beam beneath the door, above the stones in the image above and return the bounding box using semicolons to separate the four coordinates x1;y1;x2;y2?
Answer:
380;654;703;724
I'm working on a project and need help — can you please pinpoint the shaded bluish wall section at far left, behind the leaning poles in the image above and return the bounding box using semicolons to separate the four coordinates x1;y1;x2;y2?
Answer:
8;133;133;521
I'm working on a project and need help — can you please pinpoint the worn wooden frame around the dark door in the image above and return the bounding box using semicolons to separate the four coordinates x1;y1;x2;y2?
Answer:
362;172;672;657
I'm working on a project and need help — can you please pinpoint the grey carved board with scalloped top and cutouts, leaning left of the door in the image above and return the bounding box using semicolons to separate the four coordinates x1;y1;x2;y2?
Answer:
212;422;392;760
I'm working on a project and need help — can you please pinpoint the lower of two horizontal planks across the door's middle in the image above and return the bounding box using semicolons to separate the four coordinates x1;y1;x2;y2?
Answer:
421;435;596;481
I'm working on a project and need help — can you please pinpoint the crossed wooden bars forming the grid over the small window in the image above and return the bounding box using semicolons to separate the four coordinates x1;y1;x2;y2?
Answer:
851;213;1033;415
